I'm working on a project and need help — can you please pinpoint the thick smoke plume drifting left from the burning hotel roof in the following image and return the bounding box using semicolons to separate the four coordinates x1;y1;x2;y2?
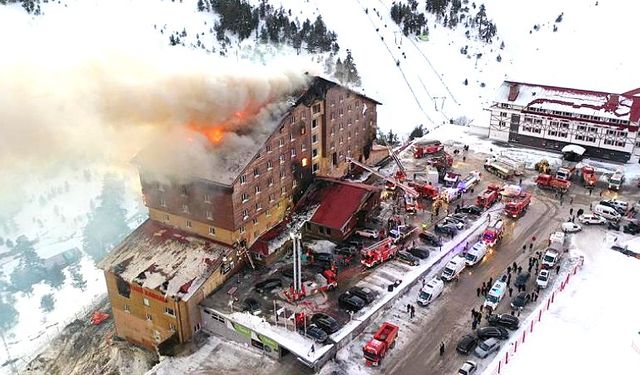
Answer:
0;2;308;191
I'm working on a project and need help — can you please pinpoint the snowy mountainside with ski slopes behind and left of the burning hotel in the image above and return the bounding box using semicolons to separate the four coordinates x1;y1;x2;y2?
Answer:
0;0;640;372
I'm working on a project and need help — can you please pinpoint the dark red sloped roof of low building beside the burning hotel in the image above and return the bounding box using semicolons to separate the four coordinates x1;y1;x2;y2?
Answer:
310;181;375;230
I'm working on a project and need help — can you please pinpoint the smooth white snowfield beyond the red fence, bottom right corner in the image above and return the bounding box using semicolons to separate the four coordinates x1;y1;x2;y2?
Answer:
500;235;640;375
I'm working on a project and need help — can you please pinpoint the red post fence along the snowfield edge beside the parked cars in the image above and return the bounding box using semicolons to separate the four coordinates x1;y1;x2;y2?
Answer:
483;257;584;375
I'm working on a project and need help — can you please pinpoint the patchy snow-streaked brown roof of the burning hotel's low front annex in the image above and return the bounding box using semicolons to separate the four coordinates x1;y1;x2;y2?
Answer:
98;220;231;300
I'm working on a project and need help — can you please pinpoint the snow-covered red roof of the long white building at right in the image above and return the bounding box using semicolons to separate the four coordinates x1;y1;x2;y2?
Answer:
496;81;640;122
